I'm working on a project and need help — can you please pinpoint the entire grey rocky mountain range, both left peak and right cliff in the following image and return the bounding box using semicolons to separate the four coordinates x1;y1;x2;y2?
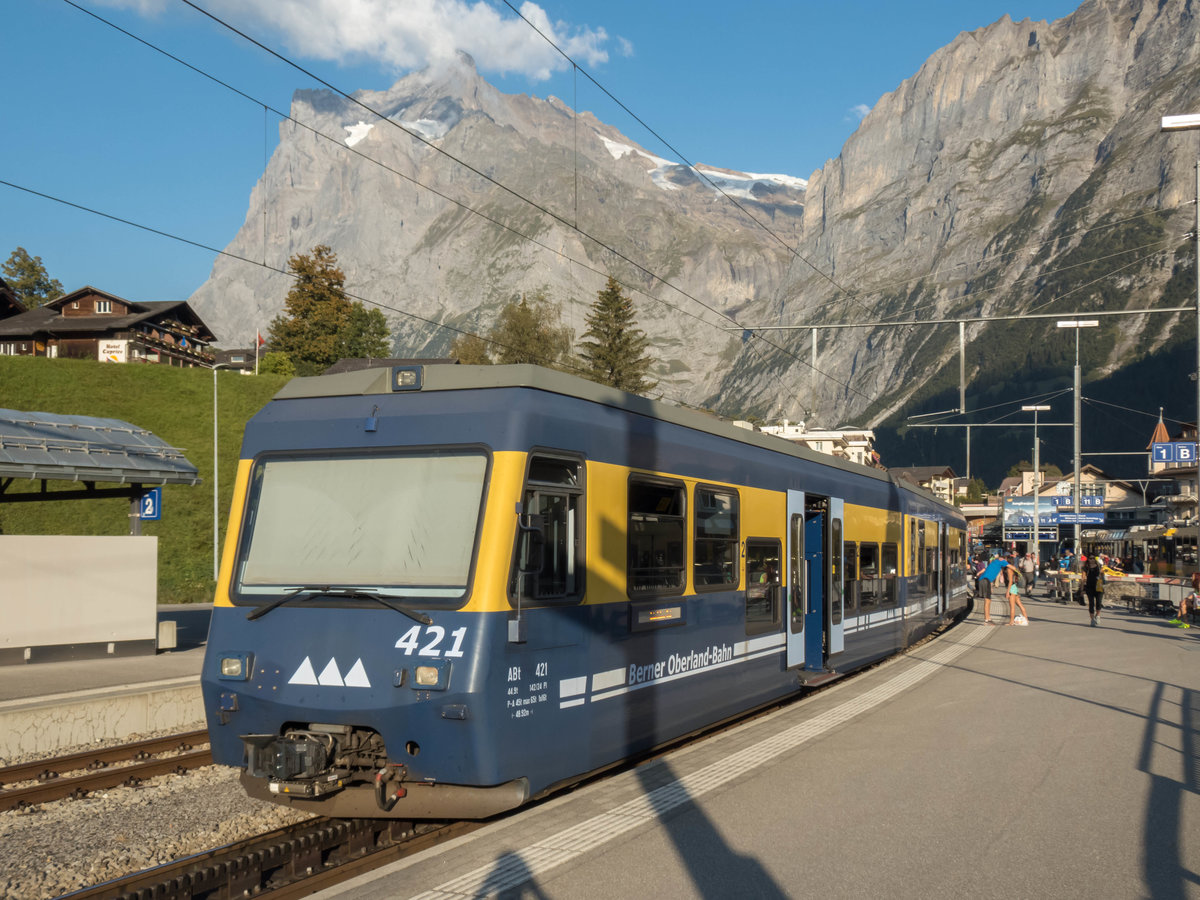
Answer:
191;0;1200;436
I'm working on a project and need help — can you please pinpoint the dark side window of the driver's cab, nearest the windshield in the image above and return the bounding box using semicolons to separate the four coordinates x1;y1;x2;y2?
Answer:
509;455;584;602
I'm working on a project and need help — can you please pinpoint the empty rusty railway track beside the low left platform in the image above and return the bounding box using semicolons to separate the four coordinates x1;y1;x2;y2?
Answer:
0;731;212;810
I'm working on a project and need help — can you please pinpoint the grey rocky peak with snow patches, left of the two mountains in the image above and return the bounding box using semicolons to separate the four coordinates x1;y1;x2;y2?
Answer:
192;59;804;401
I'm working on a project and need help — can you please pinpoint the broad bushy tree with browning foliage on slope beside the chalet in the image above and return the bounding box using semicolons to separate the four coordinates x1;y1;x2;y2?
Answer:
268;244;389;376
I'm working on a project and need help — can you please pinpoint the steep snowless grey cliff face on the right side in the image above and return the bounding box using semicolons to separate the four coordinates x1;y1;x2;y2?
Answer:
739;0;1200;424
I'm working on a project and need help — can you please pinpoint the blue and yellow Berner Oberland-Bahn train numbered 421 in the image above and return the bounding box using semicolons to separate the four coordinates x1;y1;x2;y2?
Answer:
203;365;968;818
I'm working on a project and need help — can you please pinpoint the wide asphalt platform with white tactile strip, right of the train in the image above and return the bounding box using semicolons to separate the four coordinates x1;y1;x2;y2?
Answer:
320;599;1200;900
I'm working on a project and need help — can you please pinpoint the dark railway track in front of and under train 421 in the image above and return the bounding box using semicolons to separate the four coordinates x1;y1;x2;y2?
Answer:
60;818;482;900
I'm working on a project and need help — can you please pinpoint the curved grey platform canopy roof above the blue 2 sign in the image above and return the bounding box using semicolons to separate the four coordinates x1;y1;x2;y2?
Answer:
0;409;200;491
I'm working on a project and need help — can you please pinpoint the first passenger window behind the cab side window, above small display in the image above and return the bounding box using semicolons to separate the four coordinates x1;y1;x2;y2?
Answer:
626;476;688;598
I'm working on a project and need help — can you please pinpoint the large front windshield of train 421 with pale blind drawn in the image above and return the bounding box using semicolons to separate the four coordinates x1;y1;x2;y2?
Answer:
235;451;487;601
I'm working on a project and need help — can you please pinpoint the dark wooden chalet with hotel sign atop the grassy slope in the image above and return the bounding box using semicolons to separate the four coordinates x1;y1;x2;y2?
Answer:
0;287;215;368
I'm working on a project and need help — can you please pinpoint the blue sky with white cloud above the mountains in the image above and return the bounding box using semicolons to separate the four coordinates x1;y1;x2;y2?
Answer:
0;0;1076;300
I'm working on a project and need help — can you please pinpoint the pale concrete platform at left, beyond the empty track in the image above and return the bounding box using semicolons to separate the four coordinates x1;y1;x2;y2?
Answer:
0;604;212;764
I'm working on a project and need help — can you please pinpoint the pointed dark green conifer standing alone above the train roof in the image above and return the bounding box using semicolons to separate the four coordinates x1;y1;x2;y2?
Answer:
580;276;656;394
